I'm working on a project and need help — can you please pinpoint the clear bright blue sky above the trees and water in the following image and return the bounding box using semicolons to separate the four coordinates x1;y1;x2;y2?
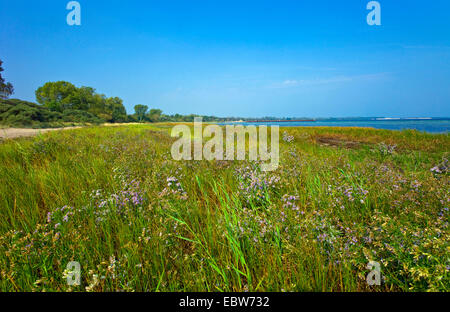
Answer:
0;0;450;117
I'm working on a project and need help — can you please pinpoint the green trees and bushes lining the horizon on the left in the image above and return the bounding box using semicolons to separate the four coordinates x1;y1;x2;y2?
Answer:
0;60;310;127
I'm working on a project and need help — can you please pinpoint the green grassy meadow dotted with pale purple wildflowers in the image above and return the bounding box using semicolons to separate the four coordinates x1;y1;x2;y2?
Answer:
0;124;450;291
